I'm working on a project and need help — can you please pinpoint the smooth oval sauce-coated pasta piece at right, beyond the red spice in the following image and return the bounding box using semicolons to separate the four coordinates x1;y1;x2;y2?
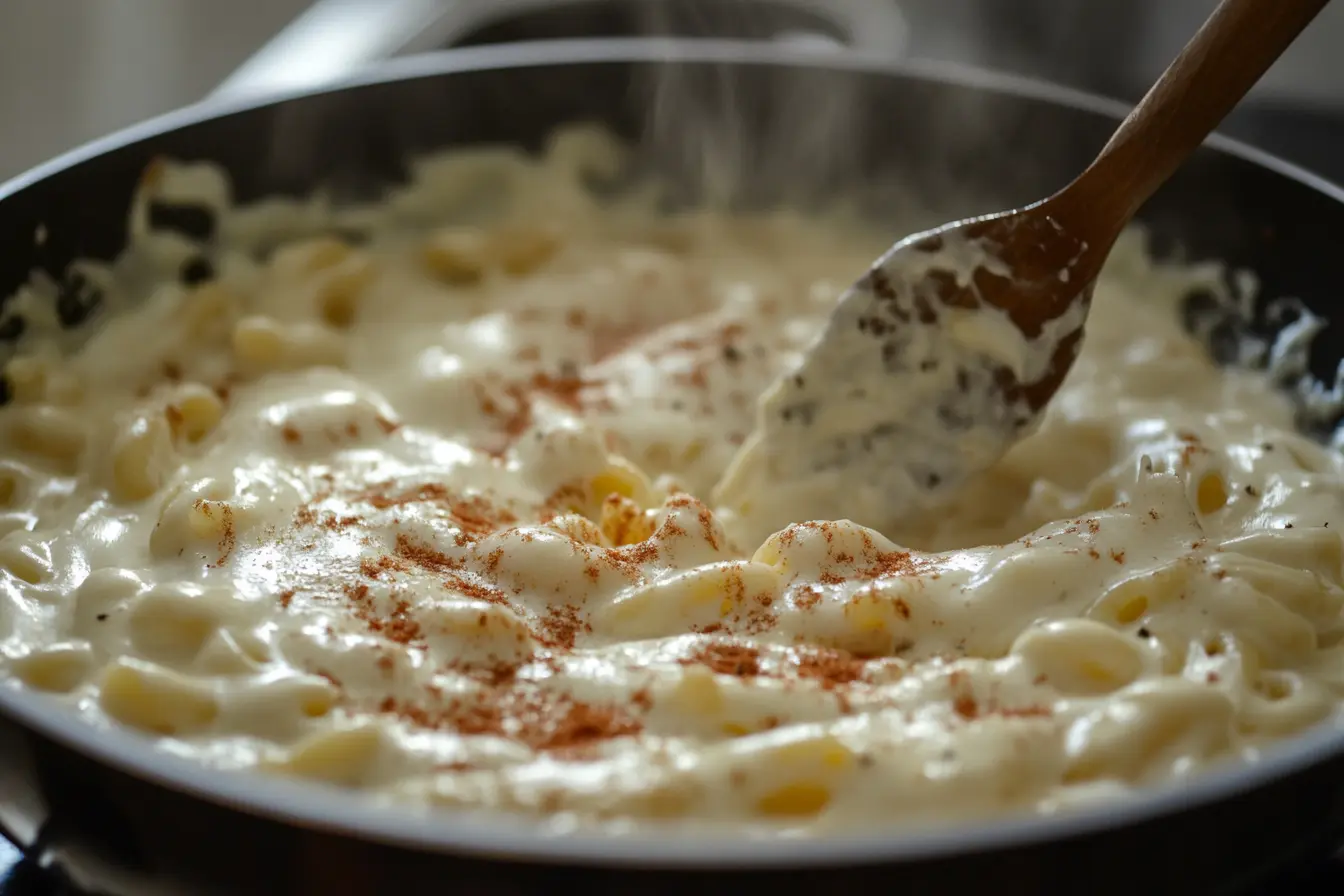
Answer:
1012;619;1148;696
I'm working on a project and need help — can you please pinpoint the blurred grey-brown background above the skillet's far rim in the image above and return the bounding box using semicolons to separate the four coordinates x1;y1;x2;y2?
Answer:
0;0;1344;180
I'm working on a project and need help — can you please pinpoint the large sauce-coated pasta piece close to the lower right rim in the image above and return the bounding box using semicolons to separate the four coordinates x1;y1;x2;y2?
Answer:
1064;680;1234;782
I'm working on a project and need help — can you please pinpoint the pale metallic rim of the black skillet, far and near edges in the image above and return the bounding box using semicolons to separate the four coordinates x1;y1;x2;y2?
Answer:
0;38;1344;870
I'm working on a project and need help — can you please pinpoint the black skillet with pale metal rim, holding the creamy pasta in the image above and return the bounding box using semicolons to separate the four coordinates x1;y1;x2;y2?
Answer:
0;40;1344;895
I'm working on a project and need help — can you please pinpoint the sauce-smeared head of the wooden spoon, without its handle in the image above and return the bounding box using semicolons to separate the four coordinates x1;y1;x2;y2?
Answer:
716;203;1109;531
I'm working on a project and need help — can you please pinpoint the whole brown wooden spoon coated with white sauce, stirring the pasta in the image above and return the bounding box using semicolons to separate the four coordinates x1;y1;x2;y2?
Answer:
715;0;1328;529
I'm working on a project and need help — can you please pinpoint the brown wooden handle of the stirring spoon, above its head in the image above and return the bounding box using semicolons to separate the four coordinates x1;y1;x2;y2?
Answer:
1056;0;1329;235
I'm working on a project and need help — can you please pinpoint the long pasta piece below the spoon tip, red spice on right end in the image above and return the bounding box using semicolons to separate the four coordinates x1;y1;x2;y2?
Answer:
599;560;780;638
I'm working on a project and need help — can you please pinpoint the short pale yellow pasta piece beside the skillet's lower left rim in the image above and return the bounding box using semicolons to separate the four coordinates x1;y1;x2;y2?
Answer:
98;657;219;736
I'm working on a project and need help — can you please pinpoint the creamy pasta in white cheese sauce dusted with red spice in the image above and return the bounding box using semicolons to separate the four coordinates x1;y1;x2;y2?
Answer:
0;129;1344;833
